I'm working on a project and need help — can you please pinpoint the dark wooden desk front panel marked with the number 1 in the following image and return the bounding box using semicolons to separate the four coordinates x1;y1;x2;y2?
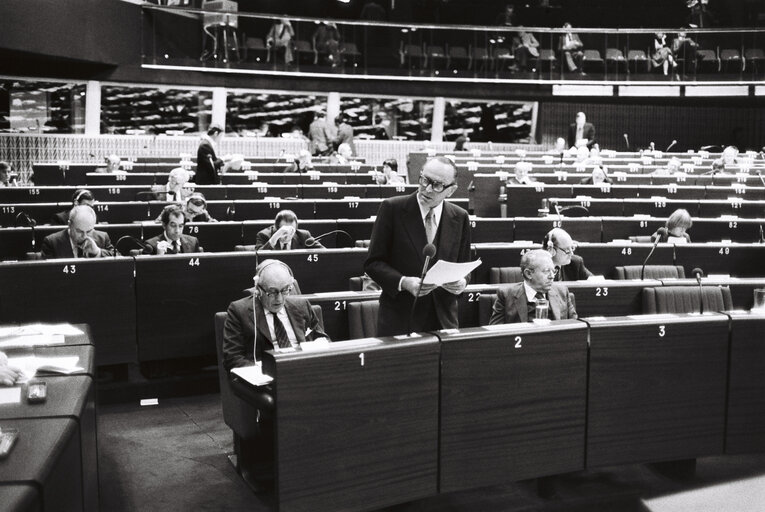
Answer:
264;337;439;512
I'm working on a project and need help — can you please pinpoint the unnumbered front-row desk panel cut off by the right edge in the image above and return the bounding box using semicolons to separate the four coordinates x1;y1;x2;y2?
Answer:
725;313;765;453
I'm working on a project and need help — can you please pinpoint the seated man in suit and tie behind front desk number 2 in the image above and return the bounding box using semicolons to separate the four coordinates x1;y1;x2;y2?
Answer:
489;249;577;325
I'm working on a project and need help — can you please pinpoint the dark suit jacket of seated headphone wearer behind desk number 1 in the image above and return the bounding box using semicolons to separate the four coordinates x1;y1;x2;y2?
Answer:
223;296;328;371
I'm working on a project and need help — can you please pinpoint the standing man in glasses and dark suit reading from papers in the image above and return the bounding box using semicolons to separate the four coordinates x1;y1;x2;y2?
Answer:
364;157;470;336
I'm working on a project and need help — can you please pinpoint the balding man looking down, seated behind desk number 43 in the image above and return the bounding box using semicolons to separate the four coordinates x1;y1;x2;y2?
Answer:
41;204;114;259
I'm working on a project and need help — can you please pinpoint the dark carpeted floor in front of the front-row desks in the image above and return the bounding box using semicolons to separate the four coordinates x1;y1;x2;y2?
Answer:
98;394;765;512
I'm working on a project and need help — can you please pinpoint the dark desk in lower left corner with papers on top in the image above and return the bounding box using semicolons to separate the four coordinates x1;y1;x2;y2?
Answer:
0;325;98;512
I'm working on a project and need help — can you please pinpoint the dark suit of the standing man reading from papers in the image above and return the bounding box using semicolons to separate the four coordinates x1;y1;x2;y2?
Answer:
364;192;470;336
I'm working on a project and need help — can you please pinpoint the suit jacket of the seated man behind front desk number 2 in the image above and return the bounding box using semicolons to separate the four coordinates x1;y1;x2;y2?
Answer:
489;283;577;325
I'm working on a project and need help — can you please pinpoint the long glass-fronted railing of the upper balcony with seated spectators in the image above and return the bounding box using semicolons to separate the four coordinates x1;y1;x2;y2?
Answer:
143;2;765;83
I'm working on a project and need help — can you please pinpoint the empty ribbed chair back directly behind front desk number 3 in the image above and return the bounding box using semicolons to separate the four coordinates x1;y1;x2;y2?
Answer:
643;286;733;314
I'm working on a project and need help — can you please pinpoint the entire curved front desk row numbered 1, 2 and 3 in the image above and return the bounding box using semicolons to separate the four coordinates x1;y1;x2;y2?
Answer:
256;313;765;512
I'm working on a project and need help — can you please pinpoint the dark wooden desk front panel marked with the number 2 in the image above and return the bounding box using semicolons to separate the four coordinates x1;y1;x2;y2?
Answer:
439;321;587;492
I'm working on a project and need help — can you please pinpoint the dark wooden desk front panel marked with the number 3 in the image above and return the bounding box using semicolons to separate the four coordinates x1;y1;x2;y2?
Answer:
587;315;728;467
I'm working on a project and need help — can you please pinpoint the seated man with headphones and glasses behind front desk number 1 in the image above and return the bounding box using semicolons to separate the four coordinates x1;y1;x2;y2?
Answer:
223;259;328;371
